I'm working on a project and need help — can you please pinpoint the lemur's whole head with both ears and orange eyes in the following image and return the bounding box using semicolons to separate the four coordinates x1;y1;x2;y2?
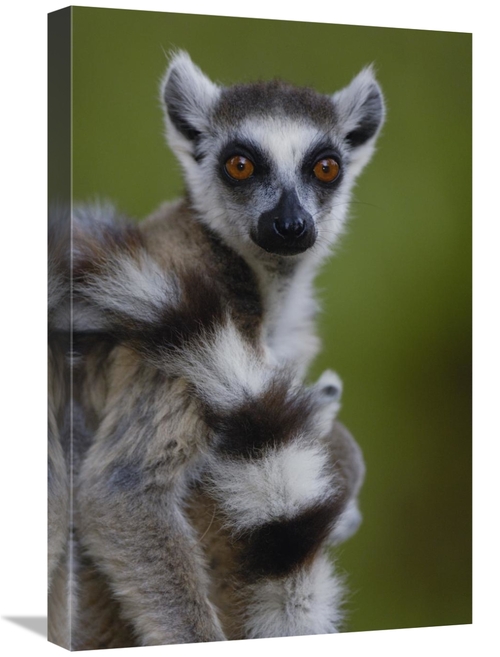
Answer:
162;52;385;259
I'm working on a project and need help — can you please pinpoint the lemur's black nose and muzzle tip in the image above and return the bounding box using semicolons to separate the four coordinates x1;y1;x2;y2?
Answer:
252;190;316;255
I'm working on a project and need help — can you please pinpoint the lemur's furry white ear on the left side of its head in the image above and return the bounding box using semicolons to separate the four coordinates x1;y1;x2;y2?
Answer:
161;51;221;150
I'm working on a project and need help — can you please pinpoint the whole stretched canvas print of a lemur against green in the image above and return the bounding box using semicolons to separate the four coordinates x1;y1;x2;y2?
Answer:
48;7;471;650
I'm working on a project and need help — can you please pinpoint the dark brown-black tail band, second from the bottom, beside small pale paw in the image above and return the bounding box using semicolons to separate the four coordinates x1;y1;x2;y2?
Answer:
207;376;313;458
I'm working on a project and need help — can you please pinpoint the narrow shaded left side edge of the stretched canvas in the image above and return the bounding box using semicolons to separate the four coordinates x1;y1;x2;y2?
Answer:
48;7;72;649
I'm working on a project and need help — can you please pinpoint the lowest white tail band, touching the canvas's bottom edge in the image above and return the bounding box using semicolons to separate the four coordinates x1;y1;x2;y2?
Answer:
245;555;343;639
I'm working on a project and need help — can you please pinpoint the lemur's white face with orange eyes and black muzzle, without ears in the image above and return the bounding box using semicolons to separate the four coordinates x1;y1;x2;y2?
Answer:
217;115;343;256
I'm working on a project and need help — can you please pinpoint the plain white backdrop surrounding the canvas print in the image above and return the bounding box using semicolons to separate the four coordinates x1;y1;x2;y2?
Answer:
0;0;492;657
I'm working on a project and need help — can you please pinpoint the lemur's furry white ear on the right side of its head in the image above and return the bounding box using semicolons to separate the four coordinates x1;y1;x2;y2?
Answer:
332;66;385;159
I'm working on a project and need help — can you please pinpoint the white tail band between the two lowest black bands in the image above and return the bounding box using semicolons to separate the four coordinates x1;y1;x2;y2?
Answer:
206;436;334;532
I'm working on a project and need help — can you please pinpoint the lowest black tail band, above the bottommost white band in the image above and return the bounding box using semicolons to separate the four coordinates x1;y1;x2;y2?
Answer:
238;500;339;581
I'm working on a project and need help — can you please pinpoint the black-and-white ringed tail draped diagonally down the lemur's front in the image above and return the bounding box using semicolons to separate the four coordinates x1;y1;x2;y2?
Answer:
55;202;362;637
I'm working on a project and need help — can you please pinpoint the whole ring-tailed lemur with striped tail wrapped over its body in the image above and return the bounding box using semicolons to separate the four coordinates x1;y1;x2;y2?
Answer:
49;53;384;649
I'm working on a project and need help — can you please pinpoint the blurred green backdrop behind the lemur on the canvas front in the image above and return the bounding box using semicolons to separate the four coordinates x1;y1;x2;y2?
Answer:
72;7;472;631
